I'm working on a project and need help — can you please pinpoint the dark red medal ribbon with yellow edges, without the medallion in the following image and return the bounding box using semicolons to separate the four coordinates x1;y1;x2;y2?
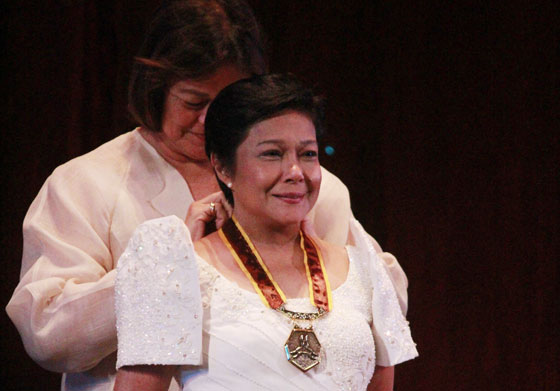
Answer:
218;216;332;311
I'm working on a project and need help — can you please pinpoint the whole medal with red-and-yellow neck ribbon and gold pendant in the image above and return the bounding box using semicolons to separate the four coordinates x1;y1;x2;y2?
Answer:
218;216;332;372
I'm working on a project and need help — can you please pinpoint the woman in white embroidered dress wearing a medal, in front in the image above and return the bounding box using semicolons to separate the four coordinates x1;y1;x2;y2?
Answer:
115;75;418;391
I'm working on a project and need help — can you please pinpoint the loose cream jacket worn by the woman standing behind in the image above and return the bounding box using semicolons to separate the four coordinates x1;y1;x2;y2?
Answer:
6;129;407;390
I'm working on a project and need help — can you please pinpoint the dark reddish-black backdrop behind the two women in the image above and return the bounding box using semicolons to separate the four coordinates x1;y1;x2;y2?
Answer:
0;0;560;391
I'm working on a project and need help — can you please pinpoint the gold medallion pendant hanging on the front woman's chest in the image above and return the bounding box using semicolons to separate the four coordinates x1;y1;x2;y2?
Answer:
284;324;321;372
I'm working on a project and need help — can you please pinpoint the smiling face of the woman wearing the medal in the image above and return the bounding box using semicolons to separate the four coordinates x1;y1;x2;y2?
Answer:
226;111;321;227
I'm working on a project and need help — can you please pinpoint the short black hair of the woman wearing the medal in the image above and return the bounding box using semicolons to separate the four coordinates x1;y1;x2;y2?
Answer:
205;74;324;205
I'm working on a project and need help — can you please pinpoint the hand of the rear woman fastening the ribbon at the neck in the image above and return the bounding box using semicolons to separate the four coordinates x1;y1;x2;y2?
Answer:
185;191;233;242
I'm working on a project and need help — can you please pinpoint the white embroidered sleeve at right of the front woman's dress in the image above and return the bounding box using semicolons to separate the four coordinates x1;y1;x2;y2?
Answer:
351;220;418;366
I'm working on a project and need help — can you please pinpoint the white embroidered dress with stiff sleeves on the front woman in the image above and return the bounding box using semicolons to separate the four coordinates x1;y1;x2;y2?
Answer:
116;216;418;391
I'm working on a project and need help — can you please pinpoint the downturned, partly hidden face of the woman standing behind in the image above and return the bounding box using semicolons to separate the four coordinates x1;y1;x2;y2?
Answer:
159;65;248;162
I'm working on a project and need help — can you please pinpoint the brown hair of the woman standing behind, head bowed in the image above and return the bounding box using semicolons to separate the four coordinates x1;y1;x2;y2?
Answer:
128;0;267;132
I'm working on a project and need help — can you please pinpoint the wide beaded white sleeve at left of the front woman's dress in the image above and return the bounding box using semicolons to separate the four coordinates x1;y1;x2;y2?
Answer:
115;216;202;368
